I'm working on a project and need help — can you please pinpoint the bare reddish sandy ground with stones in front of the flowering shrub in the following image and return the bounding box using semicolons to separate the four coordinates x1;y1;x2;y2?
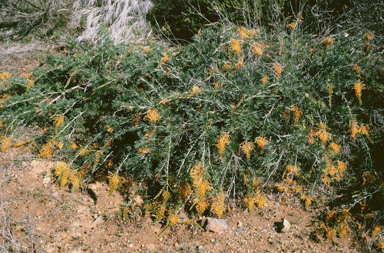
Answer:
0;148;360;252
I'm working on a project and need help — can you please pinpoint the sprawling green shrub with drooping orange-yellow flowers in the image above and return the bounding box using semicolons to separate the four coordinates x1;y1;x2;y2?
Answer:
0;22;384;224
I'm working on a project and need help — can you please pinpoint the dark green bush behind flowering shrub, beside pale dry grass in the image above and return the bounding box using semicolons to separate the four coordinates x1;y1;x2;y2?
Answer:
149;0;287;41
